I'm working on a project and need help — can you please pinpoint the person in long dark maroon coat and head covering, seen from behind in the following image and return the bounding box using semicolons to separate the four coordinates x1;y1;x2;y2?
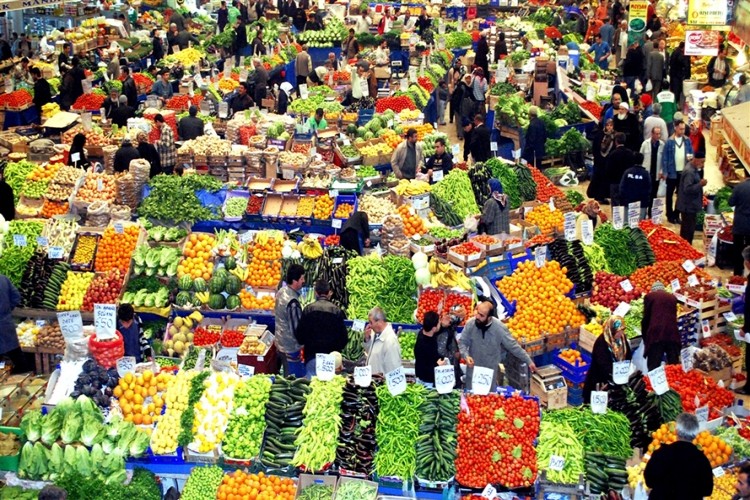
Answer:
641;281;682;371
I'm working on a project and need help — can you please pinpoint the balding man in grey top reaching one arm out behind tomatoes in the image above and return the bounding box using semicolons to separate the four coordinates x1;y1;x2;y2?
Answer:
458;301;536;390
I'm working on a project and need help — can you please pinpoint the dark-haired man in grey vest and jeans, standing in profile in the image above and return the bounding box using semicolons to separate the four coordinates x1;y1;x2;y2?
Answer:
273;264;305;377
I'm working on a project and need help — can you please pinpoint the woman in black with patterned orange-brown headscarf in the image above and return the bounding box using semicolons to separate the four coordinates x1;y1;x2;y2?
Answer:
583;316;633;404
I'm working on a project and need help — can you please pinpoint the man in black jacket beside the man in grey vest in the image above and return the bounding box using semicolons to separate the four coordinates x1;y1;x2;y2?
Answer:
294;279;349;379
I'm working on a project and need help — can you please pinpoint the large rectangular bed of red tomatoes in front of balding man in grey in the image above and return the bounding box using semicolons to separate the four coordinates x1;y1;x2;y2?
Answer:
456;394;540;488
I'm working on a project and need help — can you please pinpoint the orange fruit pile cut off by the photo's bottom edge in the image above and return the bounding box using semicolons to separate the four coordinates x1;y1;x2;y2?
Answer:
216;470;297;500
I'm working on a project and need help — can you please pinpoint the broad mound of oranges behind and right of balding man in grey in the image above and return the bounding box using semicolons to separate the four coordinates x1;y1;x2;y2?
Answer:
496;260;585;342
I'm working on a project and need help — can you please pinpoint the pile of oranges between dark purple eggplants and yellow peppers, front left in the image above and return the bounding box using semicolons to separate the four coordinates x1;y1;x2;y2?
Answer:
112;370;174;425
